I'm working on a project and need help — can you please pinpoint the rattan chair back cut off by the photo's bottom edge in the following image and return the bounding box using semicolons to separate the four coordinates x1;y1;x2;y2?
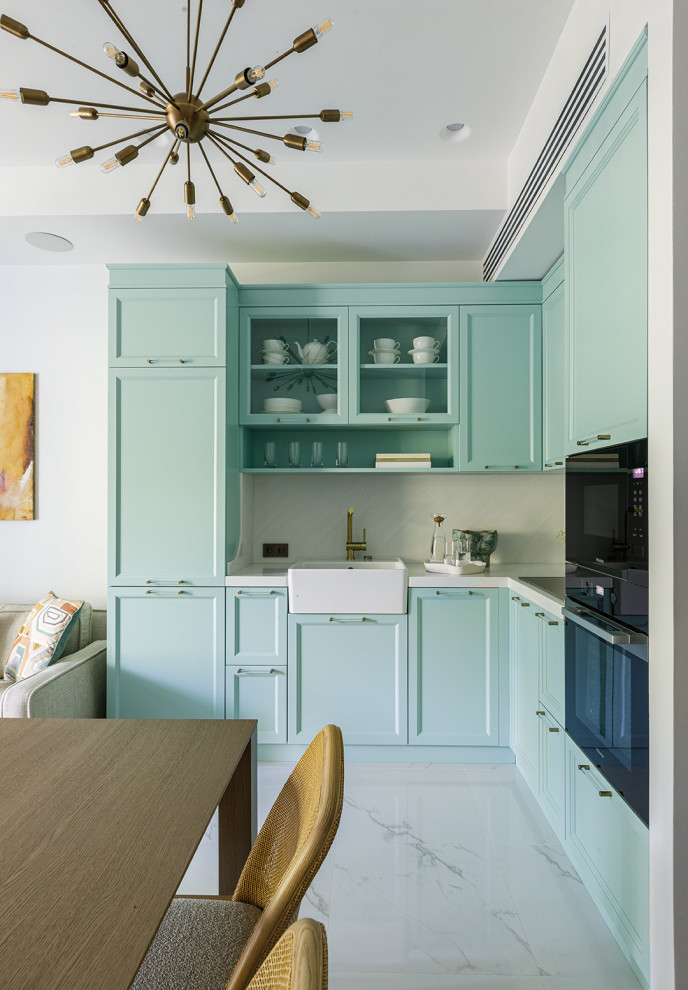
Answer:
247;918;327;990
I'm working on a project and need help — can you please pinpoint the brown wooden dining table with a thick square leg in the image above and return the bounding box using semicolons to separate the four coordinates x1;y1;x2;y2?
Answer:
0;719;256;990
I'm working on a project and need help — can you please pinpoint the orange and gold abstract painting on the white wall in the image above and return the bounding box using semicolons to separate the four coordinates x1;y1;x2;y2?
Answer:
0;372;34;520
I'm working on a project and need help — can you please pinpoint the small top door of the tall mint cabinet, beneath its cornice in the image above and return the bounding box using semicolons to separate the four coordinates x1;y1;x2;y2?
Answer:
110;288;227;368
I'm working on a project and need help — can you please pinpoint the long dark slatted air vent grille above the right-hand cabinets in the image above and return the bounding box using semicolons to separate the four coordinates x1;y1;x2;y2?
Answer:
483;25;607;282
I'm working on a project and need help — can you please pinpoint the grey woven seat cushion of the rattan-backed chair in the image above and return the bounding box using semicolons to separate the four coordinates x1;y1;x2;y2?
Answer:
131;897;262;990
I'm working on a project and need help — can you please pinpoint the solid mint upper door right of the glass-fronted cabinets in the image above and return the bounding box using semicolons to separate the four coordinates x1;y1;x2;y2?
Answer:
460;305;542;472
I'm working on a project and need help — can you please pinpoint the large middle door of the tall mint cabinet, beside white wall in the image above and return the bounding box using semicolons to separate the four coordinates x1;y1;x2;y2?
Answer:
108;368;226;587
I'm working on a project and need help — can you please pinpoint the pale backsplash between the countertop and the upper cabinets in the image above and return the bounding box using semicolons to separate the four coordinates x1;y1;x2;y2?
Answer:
247;473;564;563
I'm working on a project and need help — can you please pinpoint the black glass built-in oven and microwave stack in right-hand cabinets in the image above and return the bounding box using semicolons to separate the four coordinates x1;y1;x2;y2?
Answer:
564;440;649;822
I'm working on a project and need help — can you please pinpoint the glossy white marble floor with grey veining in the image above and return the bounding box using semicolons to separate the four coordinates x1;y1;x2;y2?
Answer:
180;764;639;990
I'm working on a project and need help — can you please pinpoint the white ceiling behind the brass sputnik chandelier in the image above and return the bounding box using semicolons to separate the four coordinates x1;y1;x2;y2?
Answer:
0;0;573;264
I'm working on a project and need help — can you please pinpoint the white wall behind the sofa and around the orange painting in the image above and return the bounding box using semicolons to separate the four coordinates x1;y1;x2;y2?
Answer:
0;265;108;608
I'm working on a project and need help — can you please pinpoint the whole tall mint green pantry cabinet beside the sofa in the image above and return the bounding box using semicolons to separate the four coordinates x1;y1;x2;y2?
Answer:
108;266;238;718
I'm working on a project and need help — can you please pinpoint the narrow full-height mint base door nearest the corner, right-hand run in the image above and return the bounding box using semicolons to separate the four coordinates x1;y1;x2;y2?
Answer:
510;595;541;794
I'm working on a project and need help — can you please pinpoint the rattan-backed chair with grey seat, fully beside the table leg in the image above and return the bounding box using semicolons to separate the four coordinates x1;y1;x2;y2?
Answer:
131;725;344;990
